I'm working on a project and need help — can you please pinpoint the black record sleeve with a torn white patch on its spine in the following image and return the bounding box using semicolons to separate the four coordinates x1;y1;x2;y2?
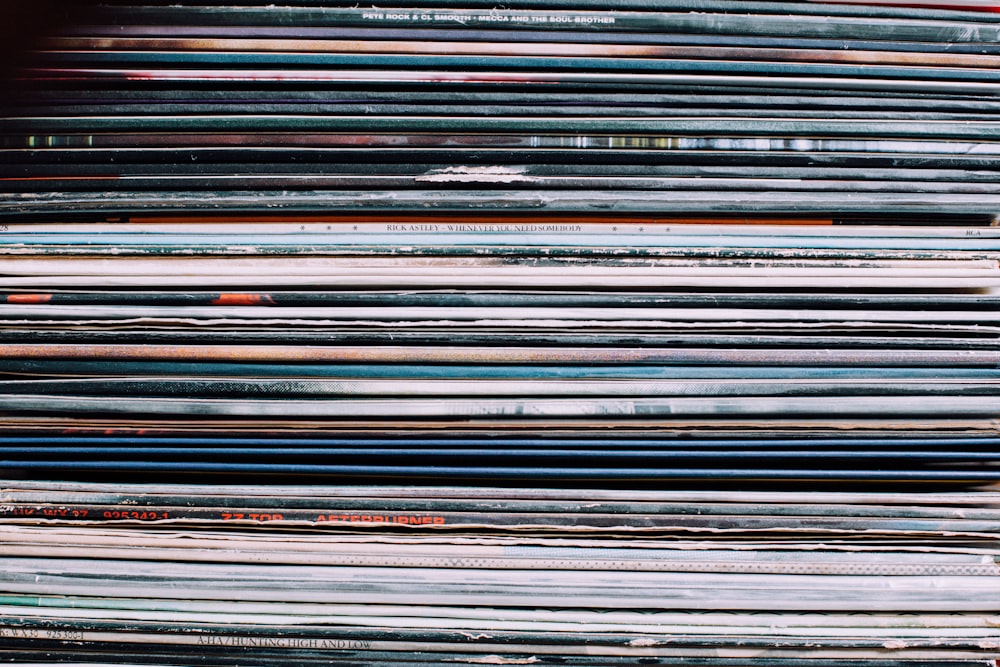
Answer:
0;170;997;190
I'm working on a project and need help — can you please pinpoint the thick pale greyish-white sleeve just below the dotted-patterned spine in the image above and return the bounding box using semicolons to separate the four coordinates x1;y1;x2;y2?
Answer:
0;556;995;612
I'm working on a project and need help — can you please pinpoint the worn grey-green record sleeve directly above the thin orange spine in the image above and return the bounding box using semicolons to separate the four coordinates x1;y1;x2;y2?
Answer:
7;190;1000;217
